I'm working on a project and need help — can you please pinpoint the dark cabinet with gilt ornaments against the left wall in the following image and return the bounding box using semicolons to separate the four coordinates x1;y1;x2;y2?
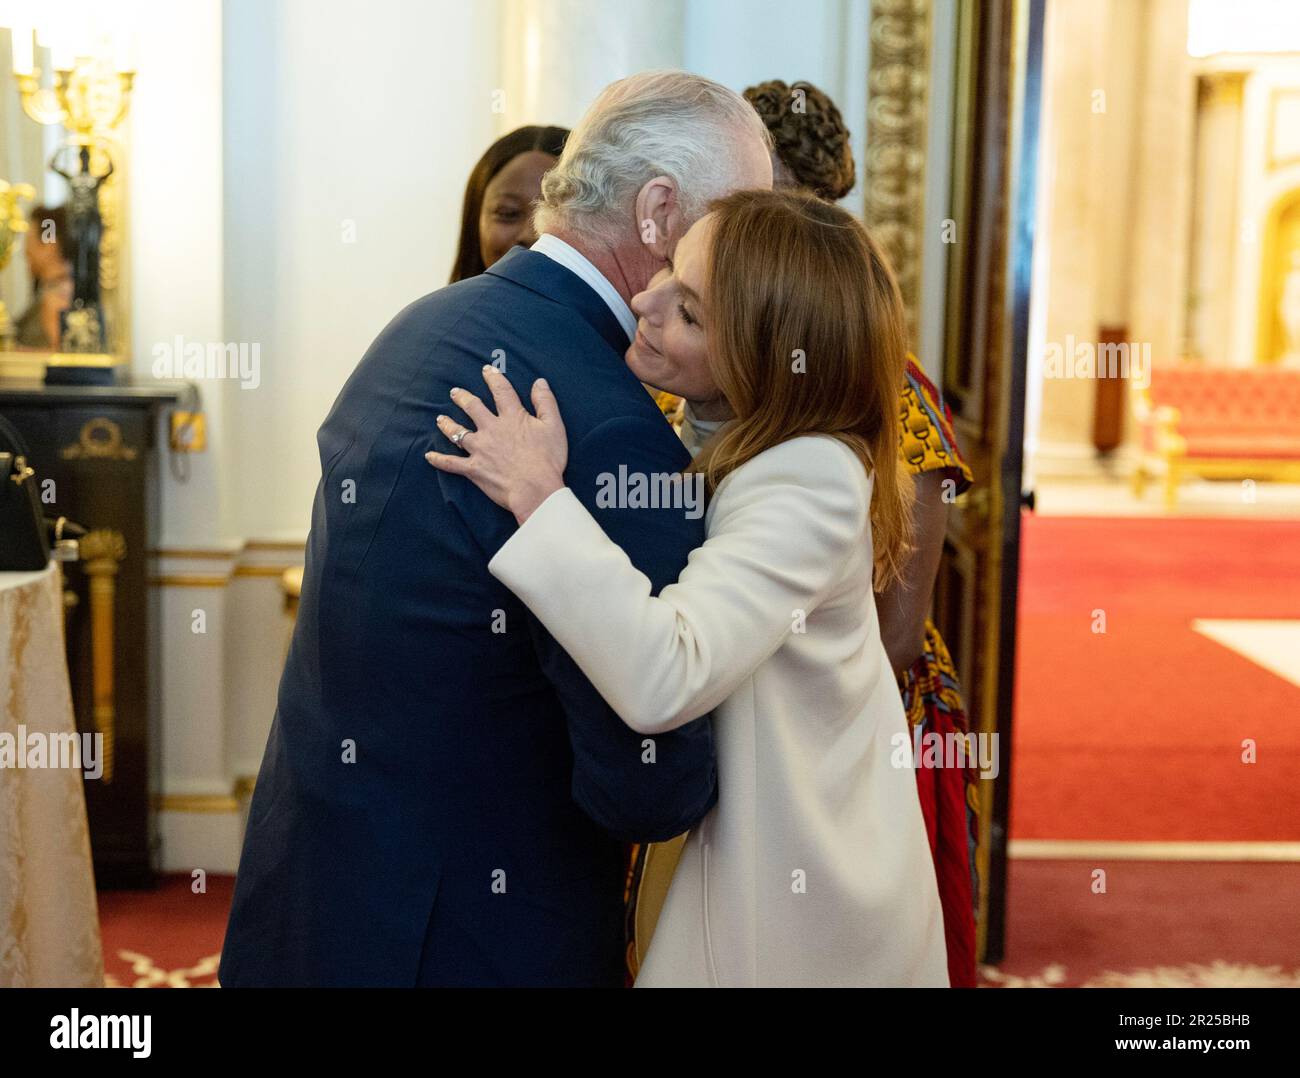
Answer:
0;382;177;887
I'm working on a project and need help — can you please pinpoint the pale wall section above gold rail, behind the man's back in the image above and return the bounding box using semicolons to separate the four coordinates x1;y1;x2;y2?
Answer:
224;0;499;537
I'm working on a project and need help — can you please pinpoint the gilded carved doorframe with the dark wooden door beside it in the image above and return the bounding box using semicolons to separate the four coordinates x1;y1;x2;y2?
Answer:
863;0;1044;962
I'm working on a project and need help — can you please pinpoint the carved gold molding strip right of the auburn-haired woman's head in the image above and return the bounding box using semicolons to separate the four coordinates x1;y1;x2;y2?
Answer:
863;0;931;341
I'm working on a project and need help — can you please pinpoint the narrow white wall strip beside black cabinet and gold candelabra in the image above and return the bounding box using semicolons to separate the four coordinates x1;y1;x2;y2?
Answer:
124;0;239;871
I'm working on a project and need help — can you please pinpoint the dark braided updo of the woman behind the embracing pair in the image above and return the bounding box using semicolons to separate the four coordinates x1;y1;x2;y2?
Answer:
745;79;857;202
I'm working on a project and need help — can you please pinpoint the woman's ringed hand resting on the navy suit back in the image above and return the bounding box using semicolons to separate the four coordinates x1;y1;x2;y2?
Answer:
425;367;568;524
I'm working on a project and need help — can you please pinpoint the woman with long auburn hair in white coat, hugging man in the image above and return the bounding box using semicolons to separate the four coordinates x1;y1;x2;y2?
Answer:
429;191;948;987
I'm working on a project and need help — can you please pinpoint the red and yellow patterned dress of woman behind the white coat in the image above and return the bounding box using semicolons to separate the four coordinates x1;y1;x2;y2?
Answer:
898;358;979;988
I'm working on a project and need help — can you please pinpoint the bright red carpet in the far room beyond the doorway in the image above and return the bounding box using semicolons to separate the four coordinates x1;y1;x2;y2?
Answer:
1010;515;1300;841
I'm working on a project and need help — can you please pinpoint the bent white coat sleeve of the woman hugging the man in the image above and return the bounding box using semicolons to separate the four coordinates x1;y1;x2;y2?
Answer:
488;436;871;733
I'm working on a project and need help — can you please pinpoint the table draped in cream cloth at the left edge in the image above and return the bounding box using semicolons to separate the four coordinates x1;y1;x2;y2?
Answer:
0;564;104;988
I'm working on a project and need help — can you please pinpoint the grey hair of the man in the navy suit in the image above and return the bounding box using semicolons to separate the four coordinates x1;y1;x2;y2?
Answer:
533;72;772;243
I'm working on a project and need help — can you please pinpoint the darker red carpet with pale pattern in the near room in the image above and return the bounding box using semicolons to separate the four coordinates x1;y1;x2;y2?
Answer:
99;861;1300;988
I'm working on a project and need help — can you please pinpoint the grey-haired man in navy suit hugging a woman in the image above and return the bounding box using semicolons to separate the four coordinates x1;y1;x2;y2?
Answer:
220;73;771;987
